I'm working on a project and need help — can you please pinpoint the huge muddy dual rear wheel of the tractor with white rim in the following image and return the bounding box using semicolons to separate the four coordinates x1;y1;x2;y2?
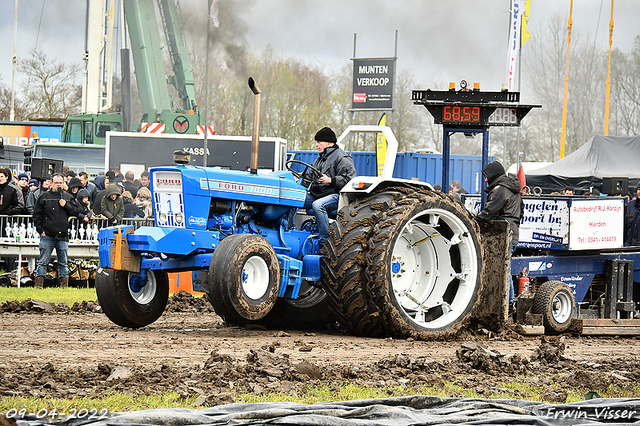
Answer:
322;187;482;338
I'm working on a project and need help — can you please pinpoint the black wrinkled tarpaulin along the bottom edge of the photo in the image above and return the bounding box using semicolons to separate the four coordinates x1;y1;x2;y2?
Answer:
12;396;640;426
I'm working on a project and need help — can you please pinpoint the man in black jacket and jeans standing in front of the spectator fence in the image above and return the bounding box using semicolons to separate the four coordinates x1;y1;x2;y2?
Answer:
33;173;79;288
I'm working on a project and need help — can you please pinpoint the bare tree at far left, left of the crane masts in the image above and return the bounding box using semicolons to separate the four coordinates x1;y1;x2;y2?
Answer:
18;50;82;119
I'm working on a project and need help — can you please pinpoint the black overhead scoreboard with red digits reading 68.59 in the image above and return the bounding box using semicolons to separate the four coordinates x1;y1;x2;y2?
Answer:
411;81;540;128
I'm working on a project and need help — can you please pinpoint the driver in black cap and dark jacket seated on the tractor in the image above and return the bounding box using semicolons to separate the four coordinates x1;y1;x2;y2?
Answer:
304;127;356;245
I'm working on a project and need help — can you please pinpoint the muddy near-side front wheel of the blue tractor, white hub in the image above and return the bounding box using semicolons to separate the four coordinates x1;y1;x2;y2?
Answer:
209;234;280;324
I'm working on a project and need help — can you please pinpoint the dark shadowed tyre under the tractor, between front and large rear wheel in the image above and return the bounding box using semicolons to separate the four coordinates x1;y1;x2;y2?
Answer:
265;281;337;330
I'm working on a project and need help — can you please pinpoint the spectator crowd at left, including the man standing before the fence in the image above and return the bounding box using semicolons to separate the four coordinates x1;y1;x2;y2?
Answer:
0;168;153;288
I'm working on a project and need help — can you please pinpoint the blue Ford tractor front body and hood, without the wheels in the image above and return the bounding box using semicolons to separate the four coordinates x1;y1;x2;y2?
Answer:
99;166;321;299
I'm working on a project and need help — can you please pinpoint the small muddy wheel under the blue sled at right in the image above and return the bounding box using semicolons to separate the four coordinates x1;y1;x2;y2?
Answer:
533;281;576;333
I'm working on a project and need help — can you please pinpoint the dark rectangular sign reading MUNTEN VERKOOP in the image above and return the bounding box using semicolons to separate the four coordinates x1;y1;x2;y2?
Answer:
351;58;396;109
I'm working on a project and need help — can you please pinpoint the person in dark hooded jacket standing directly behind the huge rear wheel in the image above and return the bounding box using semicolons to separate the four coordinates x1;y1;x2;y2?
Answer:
476;161;524;311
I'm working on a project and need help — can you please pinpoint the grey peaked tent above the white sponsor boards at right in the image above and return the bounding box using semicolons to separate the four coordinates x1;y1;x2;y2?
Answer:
526;135;640;195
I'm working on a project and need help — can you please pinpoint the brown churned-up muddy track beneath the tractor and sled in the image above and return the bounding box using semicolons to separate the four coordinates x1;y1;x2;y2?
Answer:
0;294;640;406
